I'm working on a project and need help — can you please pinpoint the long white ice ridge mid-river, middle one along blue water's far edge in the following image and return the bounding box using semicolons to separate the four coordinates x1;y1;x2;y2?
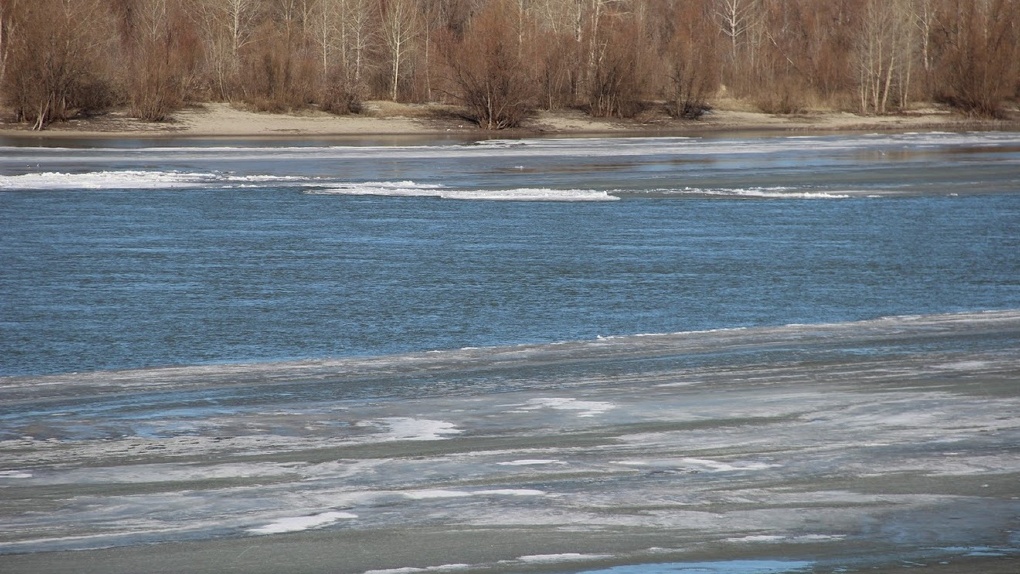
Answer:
305;181;620;202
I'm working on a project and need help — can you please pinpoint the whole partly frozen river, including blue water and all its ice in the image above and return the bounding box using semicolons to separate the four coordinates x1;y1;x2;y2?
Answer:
0;133;1020;574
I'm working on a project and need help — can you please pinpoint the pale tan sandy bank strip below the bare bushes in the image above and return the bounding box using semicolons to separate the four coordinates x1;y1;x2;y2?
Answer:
0;102;1020;141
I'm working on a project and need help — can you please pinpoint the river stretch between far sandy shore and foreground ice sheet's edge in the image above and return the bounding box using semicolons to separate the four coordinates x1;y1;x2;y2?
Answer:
0;134;1020;375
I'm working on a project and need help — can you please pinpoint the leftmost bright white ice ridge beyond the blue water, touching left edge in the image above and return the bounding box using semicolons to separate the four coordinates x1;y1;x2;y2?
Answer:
0;170;308;191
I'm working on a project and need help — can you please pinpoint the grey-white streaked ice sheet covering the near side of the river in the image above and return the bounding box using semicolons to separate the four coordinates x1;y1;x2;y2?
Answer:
0;311;1020;573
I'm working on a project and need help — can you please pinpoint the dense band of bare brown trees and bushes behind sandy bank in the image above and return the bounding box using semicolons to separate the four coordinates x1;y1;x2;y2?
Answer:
0;0;1020;128
